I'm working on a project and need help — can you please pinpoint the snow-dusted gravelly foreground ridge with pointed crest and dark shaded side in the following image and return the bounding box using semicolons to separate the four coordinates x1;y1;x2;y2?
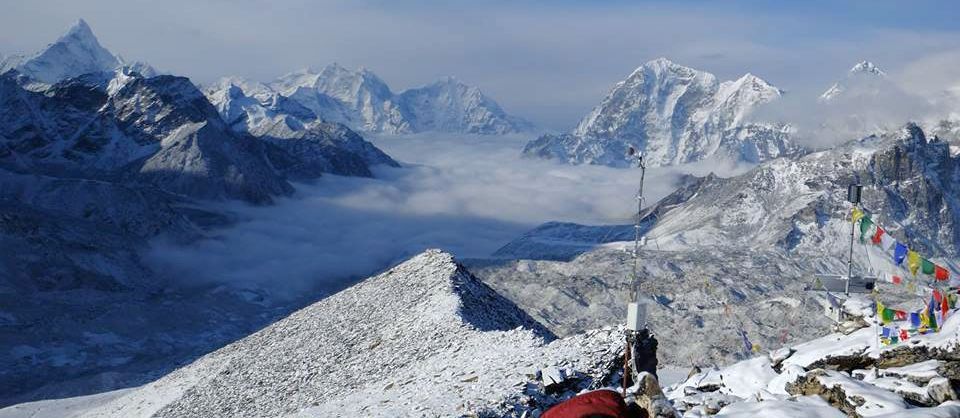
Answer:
84;250;621;416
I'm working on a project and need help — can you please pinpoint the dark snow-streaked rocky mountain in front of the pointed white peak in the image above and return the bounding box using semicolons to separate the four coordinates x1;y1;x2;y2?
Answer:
0;73;292;203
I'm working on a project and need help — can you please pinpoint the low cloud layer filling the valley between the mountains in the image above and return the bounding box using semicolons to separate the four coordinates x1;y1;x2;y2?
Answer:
148;135;745;297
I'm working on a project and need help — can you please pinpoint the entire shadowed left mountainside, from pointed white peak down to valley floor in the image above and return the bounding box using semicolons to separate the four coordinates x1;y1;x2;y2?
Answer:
0;22;397;404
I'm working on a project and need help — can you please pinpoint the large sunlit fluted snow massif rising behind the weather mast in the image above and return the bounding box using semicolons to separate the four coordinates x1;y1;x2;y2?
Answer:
524;58;799;166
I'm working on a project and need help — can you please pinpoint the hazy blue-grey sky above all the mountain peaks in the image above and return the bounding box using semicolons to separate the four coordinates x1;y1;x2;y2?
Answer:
0;0;960;129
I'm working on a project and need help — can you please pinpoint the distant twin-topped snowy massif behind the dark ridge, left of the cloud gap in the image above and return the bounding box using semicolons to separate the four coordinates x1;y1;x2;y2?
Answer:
207;63;532;135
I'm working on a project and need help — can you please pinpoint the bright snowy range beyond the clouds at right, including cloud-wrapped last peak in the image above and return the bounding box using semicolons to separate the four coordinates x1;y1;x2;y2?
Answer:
523;58;944;167
